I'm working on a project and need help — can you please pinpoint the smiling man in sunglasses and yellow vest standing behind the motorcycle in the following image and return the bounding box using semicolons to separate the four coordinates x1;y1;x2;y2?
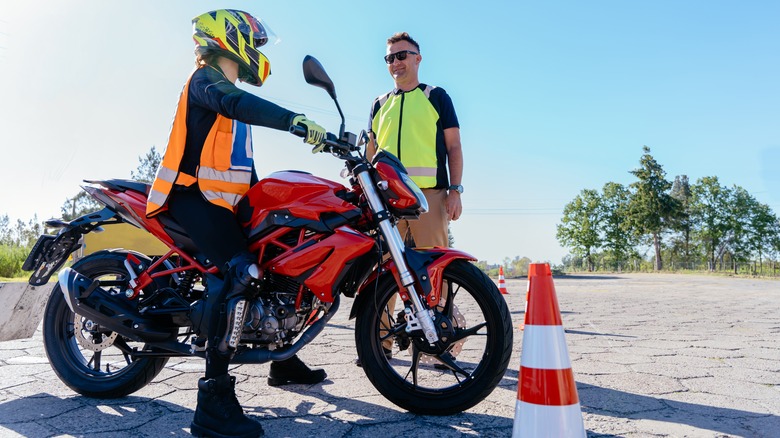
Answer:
358;32;463;365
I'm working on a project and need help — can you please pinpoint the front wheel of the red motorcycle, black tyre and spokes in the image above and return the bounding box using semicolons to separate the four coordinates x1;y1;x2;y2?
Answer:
355;260;512;415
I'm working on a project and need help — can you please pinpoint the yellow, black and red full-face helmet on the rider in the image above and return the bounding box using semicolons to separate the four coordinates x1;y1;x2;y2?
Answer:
192;9;271;87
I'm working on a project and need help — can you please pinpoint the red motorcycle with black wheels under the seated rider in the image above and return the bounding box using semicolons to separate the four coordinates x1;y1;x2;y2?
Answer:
24;56;512;415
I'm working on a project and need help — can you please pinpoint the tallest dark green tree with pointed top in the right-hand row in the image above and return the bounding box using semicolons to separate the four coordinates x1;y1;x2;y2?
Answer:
628;146;680;271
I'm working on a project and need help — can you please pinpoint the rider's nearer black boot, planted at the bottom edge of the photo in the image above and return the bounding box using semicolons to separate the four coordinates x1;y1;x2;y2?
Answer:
190;374;263;438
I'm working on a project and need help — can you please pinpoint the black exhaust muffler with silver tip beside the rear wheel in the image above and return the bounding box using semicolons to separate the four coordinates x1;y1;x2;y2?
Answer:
57;268;172;342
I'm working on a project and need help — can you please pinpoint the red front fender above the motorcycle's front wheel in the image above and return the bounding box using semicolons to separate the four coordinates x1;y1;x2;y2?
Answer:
349;247;477;319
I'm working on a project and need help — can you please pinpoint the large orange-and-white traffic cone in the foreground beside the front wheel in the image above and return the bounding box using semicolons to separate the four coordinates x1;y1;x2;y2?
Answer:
512;263;586;438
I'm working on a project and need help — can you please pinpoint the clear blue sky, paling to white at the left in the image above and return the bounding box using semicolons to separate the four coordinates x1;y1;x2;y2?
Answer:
0;0;780;263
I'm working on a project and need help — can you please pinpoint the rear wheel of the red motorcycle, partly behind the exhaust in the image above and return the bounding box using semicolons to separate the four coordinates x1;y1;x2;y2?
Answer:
43;251;168;398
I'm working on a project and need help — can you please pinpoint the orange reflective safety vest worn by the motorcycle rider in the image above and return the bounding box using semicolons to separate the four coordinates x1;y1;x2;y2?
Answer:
146;70;252;218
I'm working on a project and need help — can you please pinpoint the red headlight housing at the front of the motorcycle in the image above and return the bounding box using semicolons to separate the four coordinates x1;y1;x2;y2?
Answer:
374;151;428;218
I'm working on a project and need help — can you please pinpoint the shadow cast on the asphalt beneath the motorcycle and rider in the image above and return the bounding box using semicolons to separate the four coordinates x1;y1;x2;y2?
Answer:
0;390;513;437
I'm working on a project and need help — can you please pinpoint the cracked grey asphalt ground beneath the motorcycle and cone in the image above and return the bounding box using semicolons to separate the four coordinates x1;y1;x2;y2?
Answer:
0;274;780;437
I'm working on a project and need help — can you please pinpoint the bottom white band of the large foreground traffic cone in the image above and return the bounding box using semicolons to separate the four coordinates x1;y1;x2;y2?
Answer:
512;400;586;438
